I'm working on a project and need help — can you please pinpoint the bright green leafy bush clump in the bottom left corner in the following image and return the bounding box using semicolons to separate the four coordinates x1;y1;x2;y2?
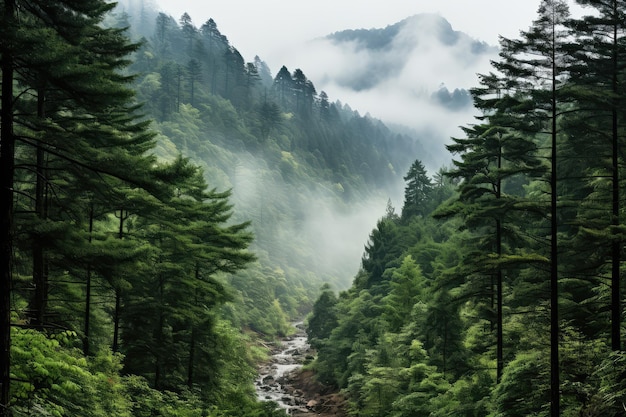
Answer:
12;329;133;417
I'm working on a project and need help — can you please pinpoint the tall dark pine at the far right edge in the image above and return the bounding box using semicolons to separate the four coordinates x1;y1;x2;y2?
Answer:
567;0;626;351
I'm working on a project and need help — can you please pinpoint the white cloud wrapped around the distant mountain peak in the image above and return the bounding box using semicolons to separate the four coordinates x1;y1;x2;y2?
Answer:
272;14;497;170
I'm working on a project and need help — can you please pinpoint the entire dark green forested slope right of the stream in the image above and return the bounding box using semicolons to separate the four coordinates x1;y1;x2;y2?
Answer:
308;0;626;417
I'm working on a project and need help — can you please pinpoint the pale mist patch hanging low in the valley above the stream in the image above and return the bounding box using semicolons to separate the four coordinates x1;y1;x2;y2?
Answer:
231;153;403;288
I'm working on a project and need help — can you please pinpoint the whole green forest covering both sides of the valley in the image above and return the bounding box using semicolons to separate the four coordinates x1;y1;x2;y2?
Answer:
0;0;626;417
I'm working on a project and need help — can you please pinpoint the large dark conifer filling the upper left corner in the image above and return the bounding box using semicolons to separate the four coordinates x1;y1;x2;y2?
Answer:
0;0;168;413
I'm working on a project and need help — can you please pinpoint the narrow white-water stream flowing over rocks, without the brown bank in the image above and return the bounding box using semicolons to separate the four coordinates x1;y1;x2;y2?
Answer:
254;322;309;415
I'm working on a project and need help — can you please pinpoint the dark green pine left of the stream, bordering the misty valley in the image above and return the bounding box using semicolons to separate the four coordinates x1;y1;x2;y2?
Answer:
120;158;253;390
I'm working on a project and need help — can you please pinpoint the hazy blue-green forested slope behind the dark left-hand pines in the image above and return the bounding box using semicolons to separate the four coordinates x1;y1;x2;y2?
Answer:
107;2;434;334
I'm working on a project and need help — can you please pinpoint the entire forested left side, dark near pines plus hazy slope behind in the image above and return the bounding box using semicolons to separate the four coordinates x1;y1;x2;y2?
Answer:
0;0;434;416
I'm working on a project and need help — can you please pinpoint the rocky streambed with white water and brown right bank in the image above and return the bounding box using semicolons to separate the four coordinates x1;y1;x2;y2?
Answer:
255;323;346;417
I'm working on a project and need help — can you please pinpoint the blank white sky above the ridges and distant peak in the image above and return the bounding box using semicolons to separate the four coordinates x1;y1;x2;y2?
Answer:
156;0;540;66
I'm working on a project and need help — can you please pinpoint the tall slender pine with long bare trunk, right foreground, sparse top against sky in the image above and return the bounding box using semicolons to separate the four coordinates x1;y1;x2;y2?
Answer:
496;0;569;417
